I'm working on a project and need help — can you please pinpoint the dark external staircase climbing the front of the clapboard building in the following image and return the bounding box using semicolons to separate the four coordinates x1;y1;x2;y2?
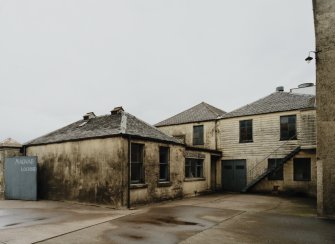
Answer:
241;144;301;193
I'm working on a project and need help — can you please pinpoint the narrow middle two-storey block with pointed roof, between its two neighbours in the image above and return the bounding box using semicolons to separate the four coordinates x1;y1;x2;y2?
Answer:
155;102;225;193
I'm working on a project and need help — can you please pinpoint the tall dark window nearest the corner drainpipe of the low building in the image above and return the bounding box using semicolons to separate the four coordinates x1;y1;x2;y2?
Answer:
130;143;144;184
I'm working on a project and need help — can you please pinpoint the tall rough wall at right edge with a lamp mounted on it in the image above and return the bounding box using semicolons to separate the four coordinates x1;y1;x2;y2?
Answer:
313;0;335;218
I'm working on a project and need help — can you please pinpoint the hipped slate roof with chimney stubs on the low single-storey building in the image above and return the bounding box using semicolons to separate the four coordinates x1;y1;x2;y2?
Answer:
25;111;181;146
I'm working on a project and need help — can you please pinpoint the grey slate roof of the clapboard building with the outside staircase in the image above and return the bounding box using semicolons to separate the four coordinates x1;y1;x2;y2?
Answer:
222;92;315;118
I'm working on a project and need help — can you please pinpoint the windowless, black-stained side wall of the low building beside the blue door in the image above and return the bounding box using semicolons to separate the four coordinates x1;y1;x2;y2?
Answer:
27;137;127;206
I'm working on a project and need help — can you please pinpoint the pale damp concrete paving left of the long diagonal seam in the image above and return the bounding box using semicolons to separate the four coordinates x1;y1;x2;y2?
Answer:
0;200;135;244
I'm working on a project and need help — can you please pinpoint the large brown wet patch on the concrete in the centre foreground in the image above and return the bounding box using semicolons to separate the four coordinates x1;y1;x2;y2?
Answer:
100;206;239;244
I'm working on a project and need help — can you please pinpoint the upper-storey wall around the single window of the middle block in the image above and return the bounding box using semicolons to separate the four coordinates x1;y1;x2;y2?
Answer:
157;121;216;150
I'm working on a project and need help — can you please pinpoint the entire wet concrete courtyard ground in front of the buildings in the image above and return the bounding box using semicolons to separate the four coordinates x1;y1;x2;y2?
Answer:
0;194;335;243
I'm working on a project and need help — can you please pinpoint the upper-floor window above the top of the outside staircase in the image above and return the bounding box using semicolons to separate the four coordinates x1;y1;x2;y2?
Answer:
280;115;297;140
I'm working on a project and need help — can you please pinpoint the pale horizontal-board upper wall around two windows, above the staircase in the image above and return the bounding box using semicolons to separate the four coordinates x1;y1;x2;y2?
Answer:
218;110;316;195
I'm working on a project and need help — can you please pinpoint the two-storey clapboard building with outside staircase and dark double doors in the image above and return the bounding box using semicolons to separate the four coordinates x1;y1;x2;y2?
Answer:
218;89;316;196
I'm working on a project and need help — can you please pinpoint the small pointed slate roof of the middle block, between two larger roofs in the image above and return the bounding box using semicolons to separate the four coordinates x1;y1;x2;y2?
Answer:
155;102;226;127
